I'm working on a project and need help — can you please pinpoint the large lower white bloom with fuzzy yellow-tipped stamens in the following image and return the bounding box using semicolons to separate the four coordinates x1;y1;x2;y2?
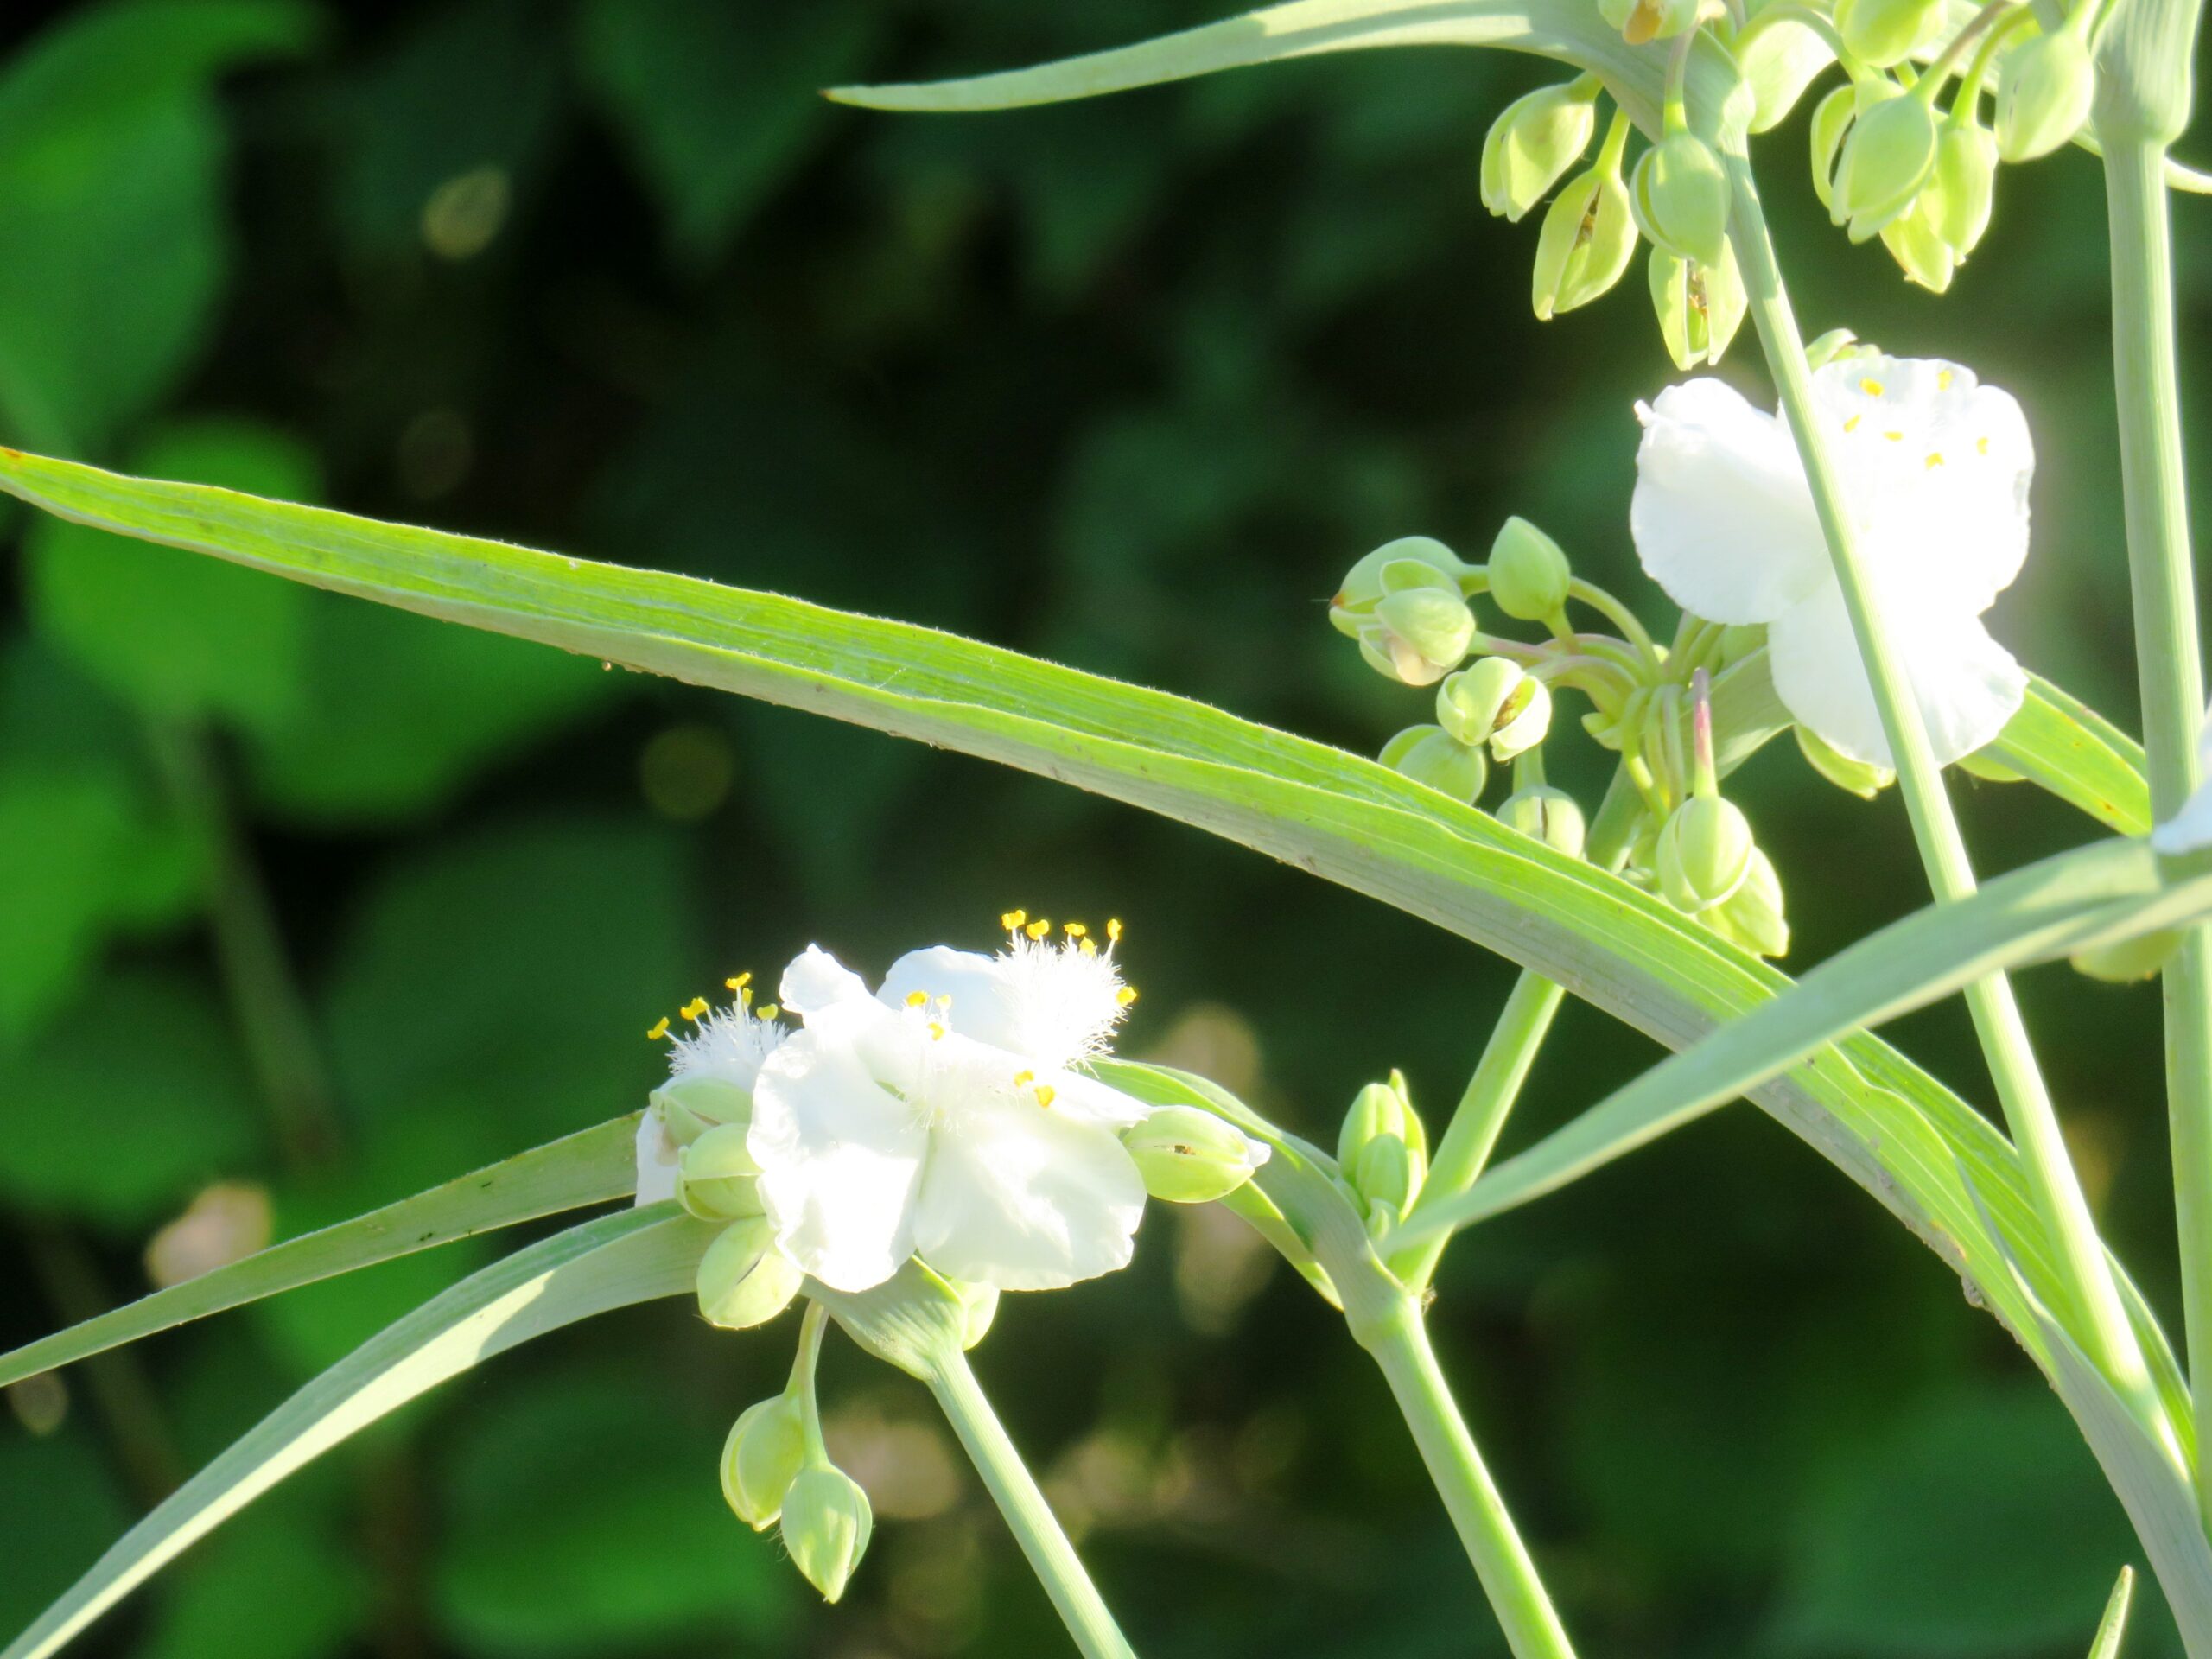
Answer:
747;912;1148;1289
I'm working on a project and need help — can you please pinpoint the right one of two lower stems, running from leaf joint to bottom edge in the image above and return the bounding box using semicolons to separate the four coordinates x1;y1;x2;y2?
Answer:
1356;1299;1575;1659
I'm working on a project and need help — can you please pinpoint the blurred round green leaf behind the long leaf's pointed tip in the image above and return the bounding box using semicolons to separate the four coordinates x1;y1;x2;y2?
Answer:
24;420;316;726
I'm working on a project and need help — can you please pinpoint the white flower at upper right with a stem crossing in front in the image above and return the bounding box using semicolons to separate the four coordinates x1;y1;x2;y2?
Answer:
1628;354;2035;766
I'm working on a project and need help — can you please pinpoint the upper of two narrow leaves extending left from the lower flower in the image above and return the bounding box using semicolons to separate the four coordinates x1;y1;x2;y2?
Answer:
0;1113;637;1387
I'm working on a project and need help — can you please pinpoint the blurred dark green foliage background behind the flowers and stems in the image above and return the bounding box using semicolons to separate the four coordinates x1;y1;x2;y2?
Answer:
0;0;2212;1659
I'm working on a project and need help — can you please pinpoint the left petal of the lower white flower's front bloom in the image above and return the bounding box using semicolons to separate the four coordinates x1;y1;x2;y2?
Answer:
746;1002;929;1289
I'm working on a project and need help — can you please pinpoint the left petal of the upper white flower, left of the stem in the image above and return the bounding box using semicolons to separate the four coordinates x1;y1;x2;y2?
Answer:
1628;378;1829;621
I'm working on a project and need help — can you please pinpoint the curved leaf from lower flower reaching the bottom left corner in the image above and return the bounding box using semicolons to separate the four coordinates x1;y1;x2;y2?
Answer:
0;1204;715;1659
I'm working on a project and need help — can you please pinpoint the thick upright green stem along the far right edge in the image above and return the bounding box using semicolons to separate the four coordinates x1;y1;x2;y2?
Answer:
2104;137;2212;1524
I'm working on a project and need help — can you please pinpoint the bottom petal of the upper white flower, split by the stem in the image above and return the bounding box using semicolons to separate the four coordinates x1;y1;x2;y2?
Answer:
1767;584;2029;766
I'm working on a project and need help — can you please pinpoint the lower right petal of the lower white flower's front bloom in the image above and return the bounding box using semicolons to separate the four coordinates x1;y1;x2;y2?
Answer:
913;1102;1144;1289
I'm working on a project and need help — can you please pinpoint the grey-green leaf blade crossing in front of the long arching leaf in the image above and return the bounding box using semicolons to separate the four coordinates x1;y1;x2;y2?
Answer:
1400;841;2212;1243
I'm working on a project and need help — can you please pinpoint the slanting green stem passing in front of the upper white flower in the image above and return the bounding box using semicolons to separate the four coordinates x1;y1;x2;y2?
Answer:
1727;150;2164;1422
